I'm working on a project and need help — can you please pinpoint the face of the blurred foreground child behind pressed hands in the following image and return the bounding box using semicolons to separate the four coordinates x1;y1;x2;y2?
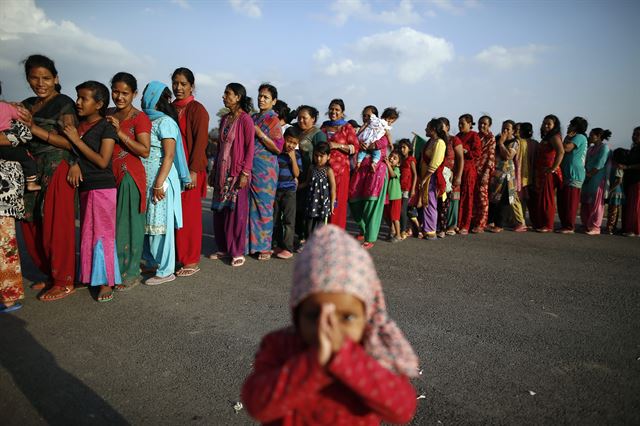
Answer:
297;293;367;346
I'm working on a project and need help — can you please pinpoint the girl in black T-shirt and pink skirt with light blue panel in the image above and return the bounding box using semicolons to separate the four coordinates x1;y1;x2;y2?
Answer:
64;81;122;302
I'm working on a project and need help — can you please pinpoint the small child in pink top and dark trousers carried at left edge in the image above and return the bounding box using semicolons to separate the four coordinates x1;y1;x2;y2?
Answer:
0;85;42;191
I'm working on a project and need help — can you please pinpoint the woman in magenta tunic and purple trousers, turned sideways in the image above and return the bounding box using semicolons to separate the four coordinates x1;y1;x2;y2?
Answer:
209;83;255;266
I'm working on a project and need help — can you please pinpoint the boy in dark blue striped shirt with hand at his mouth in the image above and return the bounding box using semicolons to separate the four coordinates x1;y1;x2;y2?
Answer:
273;127;302;259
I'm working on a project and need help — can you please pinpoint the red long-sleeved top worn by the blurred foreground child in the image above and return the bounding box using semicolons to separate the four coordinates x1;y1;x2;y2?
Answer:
242;328;416;426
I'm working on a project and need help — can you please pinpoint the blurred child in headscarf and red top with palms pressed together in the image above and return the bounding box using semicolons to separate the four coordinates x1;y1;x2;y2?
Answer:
242;225;418;425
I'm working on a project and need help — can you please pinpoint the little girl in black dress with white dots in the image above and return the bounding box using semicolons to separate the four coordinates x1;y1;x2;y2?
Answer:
301;142;336;235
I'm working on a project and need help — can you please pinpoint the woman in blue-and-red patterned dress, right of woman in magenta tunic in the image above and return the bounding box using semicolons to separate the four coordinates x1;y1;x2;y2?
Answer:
246;84;284;260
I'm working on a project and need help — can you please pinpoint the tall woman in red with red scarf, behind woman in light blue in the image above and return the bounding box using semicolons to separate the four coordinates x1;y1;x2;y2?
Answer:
171;68;209;277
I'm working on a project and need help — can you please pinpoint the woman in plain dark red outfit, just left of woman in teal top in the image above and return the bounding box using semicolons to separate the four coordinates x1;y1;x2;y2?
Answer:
529;115;564;232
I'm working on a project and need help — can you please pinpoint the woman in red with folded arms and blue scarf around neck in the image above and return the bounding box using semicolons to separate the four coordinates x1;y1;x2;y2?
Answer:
321;99;358;229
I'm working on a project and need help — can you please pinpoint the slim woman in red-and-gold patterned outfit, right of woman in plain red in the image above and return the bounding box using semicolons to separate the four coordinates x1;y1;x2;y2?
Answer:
471;115;496;234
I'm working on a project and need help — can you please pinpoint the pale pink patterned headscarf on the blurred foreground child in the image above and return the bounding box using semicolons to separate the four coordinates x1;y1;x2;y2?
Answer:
290;225;418;377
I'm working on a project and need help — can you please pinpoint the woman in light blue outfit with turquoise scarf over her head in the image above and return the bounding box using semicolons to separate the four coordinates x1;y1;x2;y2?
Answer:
142;81;191;285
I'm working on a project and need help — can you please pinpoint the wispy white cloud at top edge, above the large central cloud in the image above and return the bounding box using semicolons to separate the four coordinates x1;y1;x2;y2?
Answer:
330;0;422;26
